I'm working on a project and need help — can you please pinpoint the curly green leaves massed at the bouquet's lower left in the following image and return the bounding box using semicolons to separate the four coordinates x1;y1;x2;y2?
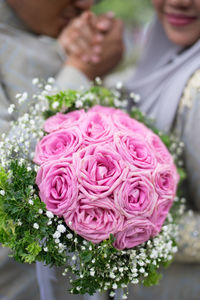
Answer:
0;161;66;265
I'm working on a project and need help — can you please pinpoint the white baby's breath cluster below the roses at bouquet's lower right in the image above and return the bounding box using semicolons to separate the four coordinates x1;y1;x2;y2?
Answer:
69;217;178;299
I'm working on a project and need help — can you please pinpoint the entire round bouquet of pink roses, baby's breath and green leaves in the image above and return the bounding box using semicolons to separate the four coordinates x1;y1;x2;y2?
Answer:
0;79;185;299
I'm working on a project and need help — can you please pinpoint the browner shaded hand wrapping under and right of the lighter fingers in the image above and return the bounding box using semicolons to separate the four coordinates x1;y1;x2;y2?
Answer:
66;20;124;80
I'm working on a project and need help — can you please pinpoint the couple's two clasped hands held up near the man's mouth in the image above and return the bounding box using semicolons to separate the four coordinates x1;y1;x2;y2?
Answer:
58;11;124;80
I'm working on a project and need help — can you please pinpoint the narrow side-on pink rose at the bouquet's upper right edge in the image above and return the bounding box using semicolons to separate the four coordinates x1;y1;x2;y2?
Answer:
147;131;173;164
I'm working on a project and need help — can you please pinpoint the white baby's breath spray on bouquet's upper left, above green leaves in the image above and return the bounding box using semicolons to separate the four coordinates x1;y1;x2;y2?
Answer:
0;78;56;171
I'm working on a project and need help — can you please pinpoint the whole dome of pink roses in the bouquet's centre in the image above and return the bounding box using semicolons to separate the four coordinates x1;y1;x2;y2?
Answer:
34;106;179;249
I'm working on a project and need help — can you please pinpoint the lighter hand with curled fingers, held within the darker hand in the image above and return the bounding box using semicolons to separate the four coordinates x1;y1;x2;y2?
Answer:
58;11;114;63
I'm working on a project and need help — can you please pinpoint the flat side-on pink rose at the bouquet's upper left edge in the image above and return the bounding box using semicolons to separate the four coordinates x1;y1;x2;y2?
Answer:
44;110;85;132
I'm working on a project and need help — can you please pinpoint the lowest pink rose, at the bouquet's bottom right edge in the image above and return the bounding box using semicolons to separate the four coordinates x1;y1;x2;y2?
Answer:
114;218;157;250
